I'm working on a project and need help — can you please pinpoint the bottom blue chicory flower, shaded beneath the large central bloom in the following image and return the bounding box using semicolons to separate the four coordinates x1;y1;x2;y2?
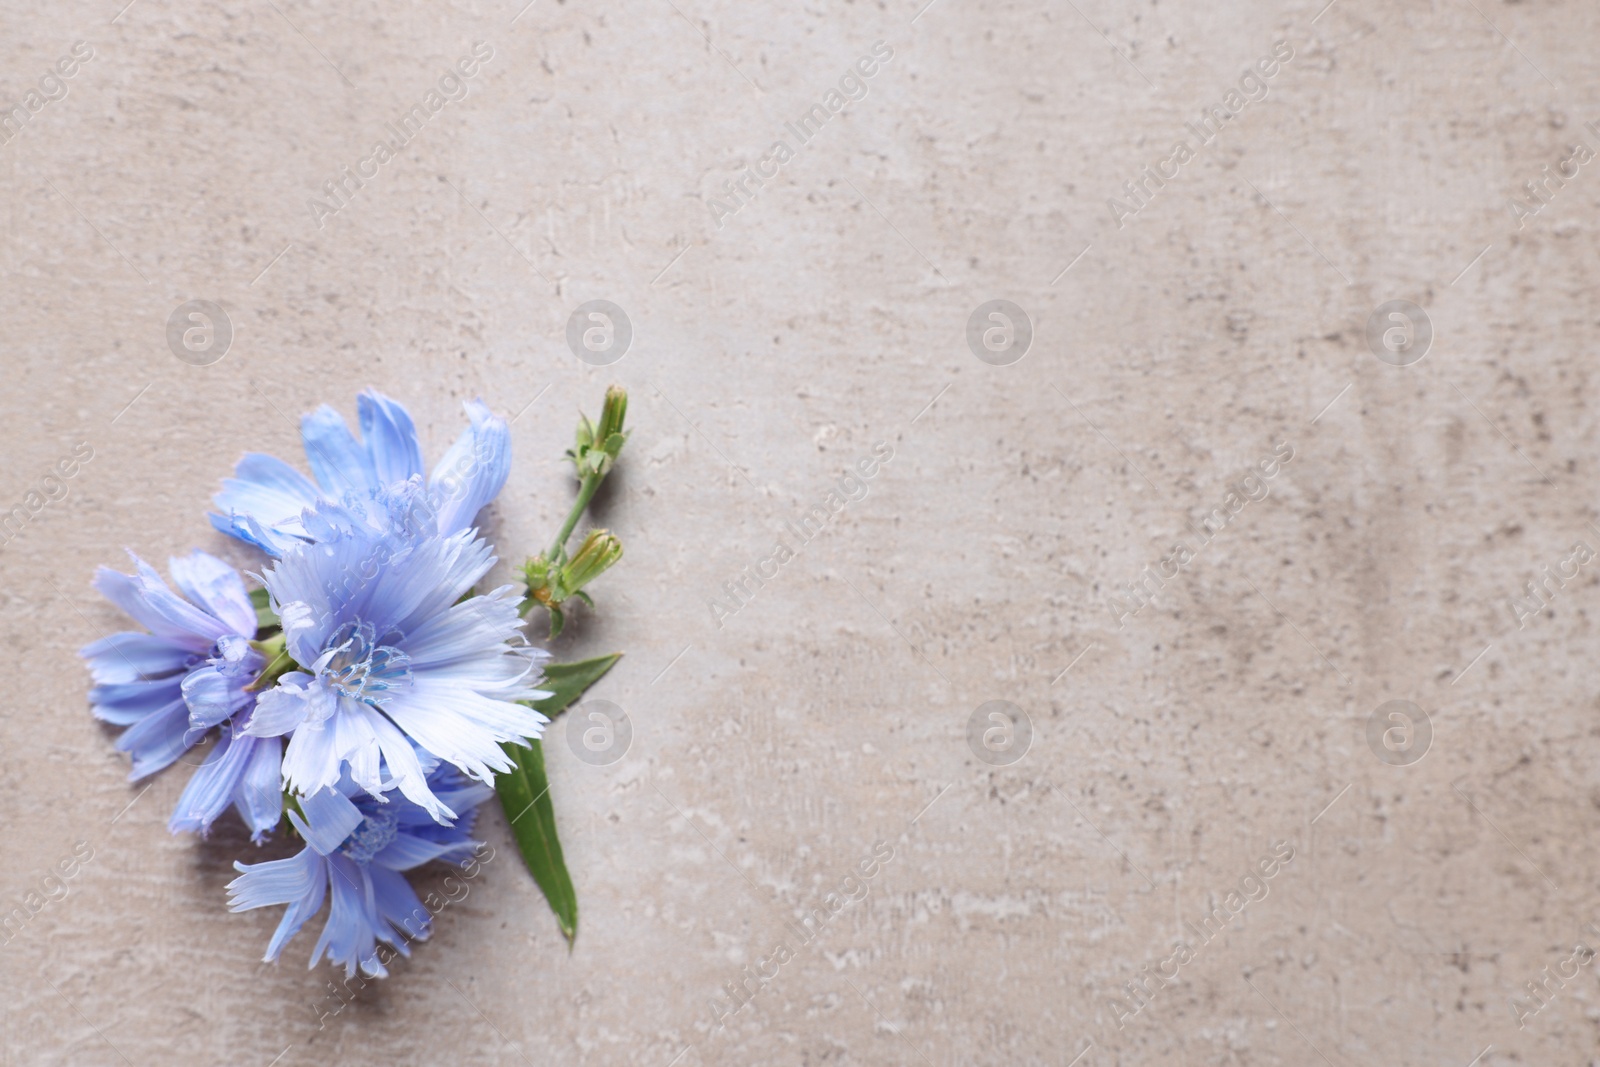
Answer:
227;764;494;977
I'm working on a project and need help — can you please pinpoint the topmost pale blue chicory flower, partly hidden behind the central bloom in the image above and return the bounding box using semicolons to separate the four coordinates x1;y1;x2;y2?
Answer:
210;390;510;558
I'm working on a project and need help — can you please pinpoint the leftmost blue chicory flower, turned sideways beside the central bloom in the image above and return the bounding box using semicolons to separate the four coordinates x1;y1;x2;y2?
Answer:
78;552;282;841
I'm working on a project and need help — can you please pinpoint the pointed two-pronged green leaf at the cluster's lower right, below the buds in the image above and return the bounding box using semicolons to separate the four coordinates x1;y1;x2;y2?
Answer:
494;653;622;945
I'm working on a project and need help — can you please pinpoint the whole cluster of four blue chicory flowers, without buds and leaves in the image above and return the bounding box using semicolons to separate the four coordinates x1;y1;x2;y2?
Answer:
82;392;549;976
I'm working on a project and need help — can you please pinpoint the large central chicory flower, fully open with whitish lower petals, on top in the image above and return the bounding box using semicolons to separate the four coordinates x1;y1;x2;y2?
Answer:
243;512;549;822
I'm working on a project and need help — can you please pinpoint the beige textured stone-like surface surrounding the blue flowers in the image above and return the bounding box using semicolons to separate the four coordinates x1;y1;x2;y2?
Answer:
0;0;1600;1067
